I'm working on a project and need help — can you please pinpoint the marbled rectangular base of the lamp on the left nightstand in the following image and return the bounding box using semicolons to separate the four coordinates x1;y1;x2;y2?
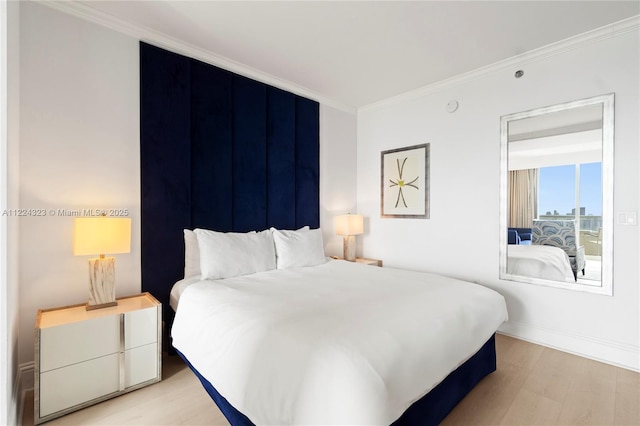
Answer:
87;257;118;311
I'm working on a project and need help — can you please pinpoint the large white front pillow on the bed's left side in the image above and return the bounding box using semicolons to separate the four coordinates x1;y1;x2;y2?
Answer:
194;229;276;280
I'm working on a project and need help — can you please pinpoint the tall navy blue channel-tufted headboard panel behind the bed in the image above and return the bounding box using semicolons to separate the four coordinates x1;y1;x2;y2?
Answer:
140;42;320;313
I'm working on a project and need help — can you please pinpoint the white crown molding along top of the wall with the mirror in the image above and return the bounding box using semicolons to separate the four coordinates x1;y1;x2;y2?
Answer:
358;15;640;113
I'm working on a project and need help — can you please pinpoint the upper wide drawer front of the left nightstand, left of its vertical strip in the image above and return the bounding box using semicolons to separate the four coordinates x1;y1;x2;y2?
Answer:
40;315;120;372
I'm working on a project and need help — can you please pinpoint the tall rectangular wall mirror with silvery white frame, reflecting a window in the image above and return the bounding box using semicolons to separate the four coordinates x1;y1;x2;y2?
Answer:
500;93;614;295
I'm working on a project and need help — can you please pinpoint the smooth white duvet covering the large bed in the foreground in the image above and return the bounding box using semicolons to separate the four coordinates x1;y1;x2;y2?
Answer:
172;261;507;425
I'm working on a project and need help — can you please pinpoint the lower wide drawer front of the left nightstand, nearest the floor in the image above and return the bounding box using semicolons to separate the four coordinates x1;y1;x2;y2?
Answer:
39;353;120;417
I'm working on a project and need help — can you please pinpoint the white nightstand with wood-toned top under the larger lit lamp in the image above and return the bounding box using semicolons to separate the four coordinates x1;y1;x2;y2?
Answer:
34;293;162;424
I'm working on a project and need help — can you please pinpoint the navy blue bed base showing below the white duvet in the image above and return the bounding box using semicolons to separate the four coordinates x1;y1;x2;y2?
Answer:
176;334;496;426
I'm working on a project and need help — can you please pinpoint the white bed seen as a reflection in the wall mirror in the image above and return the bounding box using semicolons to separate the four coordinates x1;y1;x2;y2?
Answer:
507;244;576;283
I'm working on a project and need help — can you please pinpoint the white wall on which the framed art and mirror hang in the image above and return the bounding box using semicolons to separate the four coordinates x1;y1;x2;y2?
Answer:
358;26;640;370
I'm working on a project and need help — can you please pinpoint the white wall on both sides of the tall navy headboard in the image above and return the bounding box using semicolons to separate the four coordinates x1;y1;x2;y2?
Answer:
19;2;356;372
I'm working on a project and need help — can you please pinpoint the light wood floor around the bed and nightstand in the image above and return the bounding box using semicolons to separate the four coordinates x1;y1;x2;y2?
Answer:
23;335;640;426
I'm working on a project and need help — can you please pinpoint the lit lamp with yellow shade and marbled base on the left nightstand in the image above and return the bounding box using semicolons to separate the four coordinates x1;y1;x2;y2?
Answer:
73;216;131;310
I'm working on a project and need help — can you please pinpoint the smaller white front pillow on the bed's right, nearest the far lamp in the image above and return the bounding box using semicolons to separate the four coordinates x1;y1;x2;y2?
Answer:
272;228;326;269
